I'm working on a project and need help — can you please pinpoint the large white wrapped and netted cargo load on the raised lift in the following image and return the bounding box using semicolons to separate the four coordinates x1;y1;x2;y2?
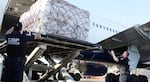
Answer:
20;0;90;40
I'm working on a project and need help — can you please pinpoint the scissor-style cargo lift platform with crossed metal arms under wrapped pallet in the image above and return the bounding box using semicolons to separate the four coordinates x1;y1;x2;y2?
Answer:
0;35;97;82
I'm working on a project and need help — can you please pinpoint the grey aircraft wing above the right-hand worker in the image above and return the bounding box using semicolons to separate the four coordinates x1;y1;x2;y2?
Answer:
98;22;150;61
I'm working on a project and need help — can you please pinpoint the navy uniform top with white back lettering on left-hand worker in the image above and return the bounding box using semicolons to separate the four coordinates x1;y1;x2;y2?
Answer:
6;31;34;57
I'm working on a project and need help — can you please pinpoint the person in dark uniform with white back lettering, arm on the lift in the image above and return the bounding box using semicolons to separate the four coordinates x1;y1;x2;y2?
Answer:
2;22;40;82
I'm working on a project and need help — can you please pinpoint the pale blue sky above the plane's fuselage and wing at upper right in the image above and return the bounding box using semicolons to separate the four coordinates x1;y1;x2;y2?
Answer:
66;0;150;26
